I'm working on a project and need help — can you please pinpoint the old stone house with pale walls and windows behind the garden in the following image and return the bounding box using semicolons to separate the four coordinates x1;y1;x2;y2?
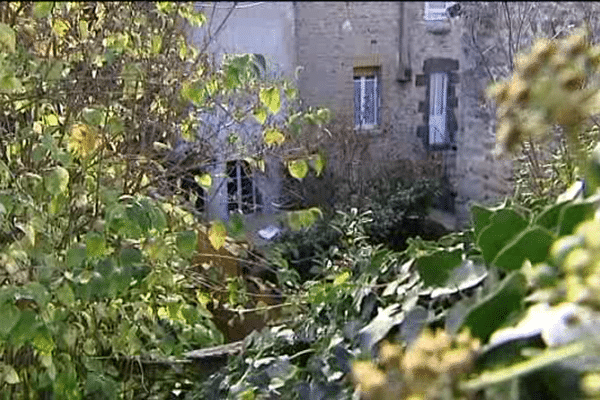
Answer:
185;1;552;227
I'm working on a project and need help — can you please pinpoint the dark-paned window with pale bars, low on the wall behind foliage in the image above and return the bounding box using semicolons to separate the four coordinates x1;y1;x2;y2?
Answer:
227;160;262;214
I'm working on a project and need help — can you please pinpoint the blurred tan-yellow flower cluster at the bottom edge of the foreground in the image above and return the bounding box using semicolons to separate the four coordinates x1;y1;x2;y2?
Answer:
352;329;480;400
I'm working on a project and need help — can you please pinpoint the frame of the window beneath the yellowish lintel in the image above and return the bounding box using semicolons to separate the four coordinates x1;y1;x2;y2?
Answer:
353;67;381;129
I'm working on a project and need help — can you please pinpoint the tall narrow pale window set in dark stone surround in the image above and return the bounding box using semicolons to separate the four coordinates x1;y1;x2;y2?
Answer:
429;72;450;145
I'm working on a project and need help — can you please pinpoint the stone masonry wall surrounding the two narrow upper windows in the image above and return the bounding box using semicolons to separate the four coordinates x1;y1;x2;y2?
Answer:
192;1;600;227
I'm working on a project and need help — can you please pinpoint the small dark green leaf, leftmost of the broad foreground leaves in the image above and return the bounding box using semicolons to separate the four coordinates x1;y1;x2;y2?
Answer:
415;248;462;286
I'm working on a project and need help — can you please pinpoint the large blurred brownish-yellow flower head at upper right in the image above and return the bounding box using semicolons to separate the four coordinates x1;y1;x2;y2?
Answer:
489;29;600;154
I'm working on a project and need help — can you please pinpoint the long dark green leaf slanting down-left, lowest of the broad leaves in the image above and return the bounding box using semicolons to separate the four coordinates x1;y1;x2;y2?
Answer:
462;271;527;343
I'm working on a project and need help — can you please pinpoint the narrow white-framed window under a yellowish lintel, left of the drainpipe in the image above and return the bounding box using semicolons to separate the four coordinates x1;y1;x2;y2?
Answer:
354;68;379;128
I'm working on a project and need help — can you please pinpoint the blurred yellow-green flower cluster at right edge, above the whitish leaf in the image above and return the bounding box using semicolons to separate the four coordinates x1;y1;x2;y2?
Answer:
550;220;600;308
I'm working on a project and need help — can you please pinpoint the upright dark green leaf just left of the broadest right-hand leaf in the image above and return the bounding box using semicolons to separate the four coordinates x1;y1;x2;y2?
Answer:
477;209;527;263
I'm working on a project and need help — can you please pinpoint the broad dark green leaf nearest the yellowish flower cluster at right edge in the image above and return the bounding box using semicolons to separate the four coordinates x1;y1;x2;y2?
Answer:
492;227;554;271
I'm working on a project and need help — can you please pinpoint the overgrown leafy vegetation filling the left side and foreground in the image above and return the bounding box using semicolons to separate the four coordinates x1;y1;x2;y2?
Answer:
5;3;600;400
